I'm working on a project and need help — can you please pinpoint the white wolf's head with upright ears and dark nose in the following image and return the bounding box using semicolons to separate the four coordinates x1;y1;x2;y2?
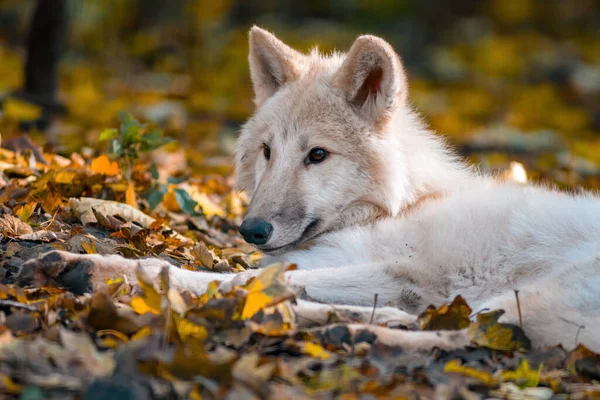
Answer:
236;27;436;253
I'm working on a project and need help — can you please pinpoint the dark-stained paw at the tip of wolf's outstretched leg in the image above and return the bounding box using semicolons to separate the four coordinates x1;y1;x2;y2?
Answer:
17;250;128;295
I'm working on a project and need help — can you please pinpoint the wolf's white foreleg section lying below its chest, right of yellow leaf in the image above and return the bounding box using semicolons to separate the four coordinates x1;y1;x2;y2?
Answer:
286;261;447;313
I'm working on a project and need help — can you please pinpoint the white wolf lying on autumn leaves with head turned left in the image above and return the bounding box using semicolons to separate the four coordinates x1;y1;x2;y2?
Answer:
22;27;600;350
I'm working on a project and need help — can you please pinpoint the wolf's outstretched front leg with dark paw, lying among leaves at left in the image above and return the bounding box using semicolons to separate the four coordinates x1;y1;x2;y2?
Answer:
18;250;255;294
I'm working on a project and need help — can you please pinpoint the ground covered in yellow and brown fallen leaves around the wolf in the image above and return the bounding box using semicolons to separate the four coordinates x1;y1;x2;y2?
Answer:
0;126;600;399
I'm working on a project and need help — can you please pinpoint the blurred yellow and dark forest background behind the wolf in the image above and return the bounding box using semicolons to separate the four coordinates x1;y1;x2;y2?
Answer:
0;0;600;188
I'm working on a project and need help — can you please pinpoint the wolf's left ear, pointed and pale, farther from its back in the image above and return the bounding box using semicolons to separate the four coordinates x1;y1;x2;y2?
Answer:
248;26;303;107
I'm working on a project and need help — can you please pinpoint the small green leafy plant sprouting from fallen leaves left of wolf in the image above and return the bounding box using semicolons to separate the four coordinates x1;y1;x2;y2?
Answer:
100;112;173;182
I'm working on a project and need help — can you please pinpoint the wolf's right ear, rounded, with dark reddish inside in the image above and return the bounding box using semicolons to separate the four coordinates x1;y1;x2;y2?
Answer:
333;35;407;125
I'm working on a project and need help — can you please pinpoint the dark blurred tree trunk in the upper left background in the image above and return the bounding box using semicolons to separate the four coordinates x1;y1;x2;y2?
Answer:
23;0;68;112
